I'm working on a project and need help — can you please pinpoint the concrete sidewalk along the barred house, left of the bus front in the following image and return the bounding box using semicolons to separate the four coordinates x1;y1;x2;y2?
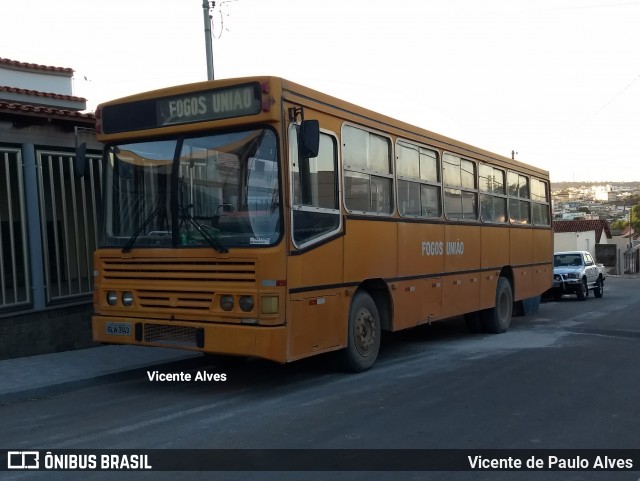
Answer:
0;345;201;403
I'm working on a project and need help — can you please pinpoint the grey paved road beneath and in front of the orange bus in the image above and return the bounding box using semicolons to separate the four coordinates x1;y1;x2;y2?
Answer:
0;277;640;481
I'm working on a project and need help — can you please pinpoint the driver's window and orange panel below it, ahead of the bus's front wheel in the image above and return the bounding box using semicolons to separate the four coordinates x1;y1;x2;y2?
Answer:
286;110;349;359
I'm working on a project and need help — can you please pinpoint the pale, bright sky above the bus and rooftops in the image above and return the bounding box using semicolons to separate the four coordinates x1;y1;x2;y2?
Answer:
0;0;640;181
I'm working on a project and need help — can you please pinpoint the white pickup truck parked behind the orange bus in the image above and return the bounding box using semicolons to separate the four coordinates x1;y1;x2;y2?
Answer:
547;251;605;301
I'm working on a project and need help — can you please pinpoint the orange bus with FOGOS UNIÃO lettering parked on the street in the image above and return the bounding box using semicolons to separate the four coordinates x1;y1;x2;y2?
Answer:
87;77;553;372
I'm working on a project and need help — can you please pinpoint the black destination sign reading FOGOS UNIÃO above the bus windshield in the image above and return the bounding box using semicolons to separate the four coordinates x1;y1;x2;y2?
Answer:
101;82;262;134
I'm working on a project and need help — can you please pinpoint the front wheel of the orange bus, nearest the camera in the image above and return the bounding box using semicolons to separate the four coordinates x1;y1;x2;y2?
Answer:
339;291;382;372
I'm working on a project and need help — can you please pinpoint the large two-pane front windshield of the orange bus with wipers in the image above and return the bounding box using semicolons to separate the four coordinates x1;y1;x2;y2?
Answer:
101;125;282;252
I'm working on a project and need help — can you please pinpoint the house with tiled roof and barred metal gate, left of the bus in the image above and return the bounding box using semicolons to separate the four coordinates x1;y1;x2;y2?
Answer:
0;58;101;359
